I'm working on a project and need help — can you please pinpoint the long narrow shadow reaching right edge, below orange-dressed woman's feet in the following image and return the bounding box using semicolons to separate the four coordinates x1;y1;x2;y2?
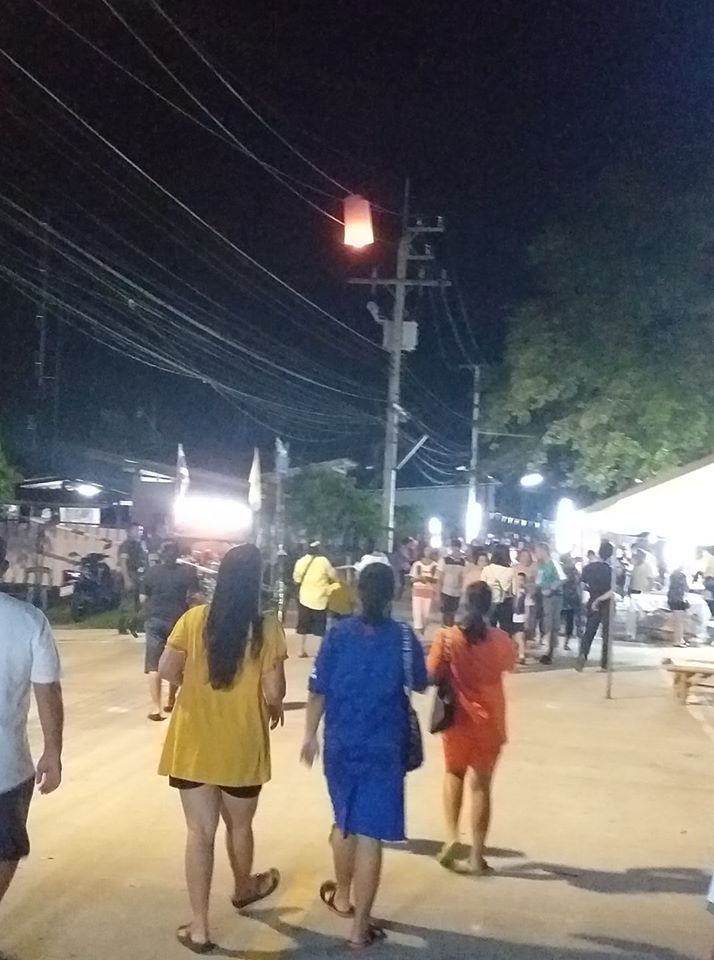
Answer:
498;863;710;896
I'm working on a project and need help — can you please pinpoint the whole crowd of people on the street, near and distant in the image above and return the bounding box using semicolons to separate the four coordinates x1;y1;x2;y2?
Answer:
0;528;708;954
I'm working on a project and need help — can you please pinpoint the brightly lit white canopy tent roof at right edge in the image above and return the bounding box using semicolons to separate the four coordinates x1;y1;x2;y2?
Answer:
579;455;714;552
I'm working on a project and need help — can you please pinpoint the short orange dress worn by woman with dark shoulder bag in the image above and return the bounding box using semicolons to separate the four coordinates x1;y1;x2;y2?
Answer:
427;627;516;775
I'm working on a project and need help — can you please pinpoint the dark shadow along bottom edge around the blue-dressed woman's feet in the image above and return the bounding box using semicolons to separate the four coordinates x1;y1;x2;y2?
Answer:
213;908;689;960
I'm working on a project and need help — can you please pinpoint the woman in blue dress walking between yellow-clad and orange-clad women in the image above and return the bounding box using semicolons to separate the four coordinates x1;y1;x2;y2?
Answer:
301;563;427;949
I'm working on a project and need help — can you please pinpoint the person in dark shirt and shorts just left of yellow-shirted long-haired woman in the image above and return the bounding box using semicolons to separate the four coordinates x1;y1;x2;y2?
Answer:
142;540;199;721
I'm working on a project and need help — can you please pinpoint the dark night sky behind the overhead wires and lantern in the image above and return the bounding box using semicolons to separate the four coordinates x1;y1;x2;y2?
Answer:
0;0;714;477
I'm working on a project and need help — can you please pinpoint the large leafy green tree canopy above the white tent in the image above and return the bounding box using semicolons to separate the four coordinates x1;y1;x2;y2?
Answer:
496;165;714;495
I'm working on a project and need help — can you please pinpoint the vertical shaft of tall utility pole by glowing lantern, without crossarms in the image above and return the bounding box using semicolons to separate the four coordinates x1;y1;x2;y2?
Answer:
382;180;411;553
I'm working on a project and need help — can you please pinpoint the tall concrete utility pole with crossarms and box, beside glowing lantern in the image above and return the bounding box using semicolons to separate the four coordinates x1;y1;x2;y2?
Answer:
349;180;450;553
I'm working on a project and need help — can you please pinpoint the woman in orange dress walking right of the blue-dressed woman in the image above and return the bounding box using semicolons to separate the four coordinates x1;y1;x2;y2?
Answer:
428;581;516;876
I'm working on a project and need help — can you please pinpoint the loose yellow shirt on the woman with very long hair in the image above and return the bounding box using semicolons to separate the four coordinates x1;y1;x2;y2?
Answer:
159;604;287;787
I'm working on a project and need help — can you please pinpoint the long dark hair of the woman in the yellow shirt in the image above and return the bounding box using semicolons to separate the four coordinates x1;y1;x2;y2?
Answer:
203;543;263;690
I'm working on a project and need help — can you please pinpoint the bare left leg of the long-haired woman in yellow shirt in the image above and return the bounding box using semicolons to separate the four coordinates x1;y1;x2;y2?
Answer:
180;786;221;943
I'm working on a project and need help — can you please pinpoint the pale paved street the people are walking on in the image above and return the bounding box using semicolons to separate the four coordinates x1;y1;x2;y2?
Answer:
0;638;714;960
